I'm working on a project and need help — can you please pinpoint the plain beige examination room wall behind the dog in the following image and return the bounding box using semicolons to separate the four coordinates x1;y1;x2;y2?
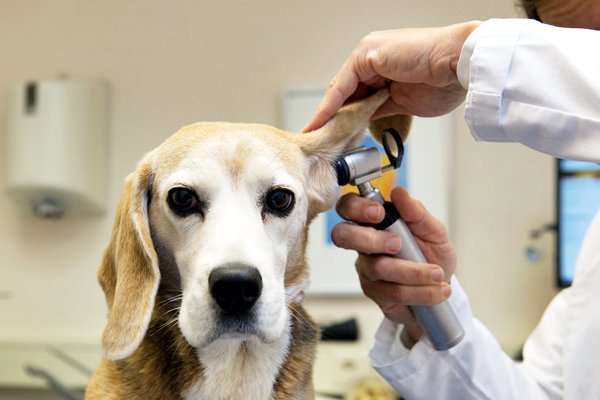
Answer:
0;0;553;384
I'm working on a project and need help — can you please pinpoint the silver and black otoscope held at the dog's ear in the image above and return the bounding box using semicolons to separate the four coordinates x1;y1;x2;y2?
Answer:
334;129;464;350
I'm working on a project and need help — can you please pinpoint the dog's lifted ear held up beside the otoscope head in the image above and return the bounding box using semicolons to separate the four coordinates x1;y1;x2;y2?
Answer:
297;90;410;217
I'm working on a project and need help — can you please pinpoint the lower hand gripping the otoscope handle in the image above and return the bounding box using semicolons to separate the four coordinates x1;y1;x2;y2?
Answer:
331;188;456;341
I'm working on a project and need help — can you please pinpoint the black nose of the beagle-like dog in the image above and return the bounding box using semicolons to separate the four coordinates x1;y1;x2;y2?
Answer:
208;264;262;315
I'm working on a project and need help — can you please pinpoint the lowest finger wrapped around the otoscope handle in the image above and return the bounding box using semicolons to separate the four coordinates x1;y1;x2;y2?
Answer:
359;276;451;307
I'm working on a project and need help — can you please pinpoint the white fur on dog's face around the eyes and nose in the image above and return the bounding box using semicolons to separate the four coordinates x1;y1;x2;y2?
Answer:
152;132;308;348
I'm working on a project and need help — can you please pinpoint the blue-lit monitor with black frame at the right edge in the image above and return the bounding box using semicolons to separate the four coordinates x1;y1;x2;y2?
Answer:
556;160;600;287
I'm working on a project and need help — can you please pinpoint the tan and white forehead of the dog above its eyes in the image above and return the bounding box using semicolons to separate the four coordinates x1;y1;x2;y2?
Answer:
153;122;304;184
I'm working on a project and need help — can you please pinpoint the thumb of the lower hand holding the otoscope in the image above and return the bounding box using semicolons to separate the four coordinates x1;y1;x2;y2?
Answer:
391;187;448;243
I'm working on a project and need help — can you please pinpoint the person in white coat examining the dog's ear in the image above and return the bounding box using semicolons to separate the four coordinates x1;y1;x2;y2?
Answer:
305;0;600;400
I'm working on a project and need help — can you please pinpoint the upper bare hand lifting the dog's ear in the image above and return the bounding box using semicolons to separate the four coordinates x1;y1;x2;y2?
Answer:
303;21;480;132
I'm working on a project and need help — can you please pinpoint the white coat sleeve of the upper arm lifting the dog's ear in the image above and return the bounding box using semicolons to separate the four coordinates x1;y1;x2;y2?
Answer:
457;19;600;162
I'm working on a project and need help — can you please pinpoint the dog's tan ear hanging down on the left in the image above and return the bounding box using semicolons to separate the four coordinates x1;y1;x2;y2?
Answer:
98;160;160;360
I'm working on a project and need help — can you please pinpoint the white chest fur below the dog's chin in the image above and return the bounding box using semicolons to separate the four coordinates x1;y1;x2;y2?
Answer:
183;335;289;400
